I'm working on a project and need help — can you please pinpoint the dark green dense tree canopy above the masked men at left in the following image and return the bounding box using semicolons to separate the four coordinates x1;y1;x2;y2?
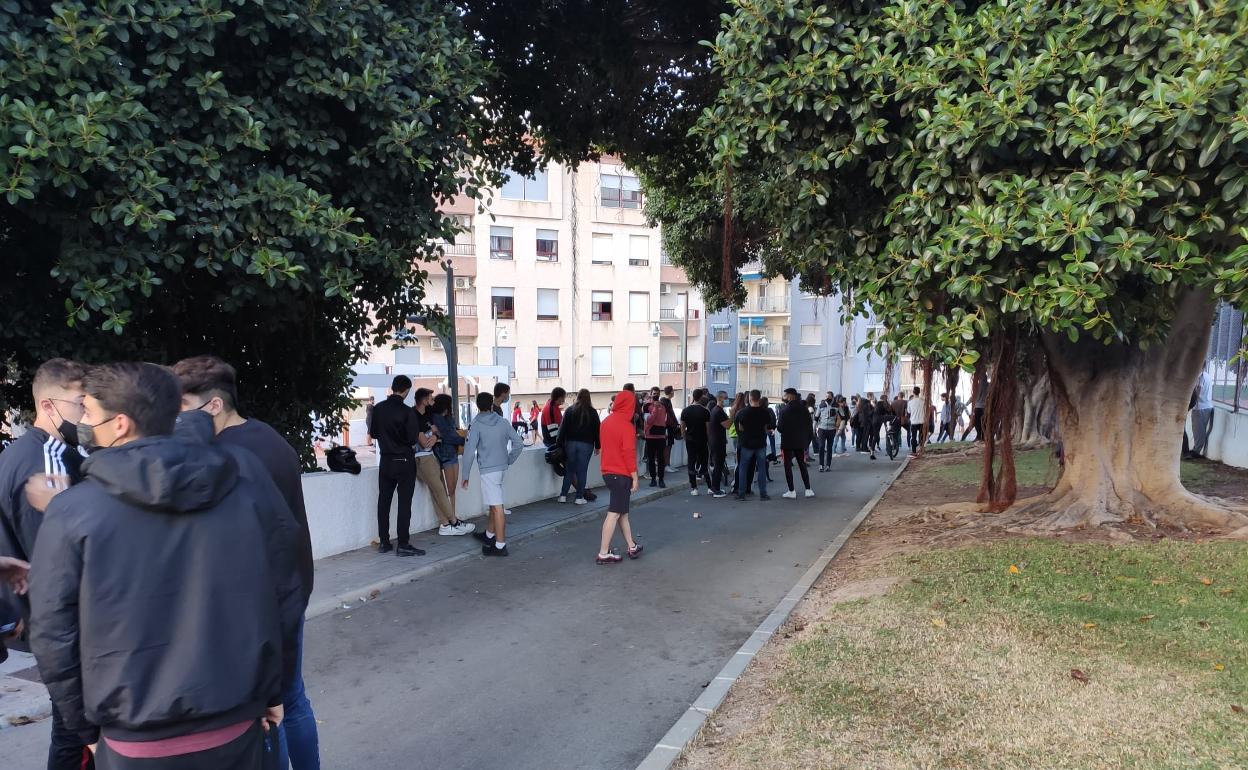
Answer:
0;0;518;461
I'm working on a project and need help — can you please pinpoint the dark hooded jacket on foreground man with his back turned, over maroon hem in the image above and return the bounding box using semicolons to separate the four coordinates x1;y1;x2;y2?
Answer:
30;436;306;743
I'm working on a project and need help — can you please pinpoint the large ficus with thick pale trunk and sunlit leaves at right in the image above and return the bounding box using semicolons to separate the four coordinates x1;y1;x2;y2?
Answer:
669;0;1248;529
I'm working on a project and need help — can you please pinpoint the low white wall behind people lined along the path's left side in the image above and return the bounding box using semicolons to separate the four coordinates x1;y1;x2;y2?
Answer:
303;442;685;559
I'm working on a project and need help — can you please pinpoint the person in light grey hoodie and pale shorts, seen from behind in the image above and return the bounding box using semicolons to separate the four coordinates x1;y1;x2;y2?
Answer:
463;393;524;557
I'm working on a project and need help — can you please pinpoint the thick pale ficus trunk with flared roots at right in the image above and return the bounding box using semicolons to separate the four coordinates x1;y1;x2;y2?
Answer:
1023;291;1248;537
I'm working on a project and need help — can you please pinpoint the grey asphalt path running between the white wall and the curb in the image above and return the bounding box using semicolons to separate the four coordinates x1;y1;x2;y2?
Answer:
0;454;896;770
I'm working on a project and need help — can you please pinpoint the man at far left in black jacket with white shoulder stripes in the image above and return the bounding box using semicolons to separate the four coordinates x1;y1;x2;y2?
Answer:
0;358;92;770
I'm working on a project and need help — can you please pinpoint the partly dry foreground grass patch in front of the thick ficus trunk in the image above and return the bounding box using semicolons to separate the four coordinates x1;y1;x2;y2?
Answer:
698;540;1248;770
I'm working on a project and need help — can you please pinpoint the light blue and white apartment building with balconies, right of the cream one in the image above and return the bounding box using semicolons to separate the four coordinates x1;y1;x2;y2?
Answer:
705;265;910;401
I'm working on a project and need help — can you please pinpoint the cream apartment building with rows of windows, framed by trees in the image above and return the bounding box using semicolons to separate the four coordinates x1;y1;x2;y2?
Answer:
371;157;704;406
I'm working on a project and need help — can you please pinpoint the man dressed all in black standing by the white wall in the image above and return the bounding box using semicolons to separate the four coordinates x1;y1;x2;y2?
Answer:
368;374;432;557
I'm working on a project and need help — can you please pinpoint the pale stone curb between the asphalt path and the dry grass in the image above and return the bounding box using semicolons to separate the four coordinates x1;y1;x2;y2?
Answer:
636;454;910;770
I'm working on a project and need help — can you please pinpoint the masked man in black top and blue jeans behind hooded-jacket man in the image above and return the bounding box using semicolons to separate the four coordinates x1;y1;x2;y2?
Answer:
173;356;321;770
